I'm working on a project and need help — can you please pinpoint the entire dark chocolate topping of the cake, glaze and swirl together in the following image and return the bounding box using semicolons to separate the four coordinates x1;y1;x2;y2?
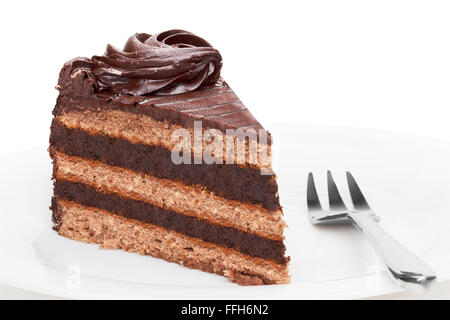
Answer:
53;30;271;144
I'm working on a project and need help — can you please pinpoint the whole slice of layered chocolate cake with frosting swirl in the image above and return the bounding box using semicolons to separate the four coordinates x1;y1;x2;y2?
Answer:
49;30;289;285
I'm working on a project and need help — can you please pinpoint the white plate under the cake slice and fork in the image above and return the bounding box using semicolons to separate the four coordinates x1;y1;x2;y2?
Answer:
0;125;450;299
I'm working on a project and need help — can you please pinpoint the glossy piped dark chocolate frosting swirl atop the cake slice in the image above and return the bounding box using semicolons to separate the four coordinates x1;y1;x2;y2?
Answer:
58;30;222;96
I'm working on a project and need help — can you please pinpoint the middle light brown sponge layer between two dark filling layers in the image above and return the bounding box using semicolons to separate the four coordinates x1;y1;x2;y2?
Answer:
54;152;285;240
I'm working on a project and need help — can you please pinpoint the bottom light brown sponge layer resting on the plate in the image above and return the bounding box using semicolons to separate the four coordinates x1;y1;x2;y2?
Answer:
57;200;290;285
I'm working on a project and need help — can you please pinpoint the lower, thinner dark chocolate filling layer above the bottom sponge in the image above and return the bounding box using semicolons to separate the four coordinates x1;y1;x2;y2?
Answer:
52;180;287;264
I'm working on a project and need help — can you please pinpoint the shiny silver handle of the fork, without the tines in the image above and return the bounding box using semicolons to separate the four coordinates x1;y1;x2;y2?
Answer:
348;212;436;288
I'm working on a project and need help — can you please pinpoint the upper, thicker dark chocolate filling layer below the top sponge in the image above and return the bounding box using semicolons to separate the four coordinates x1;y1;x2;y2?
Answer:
50;120;280;210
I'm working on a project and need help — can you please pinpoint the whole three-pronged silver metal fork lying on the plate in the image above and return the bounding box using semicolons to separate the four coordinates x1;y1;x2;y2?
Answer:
307;171;436;289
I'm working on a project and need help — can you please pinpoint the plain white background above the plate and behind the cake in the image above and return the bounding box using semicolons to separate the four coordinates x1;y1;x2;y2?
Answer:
0;0;450;298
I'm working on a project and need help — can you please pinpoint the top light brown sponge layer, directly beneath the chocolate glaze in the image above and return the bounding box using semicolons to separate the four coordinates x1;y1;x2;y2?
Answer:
52;107;271;168
